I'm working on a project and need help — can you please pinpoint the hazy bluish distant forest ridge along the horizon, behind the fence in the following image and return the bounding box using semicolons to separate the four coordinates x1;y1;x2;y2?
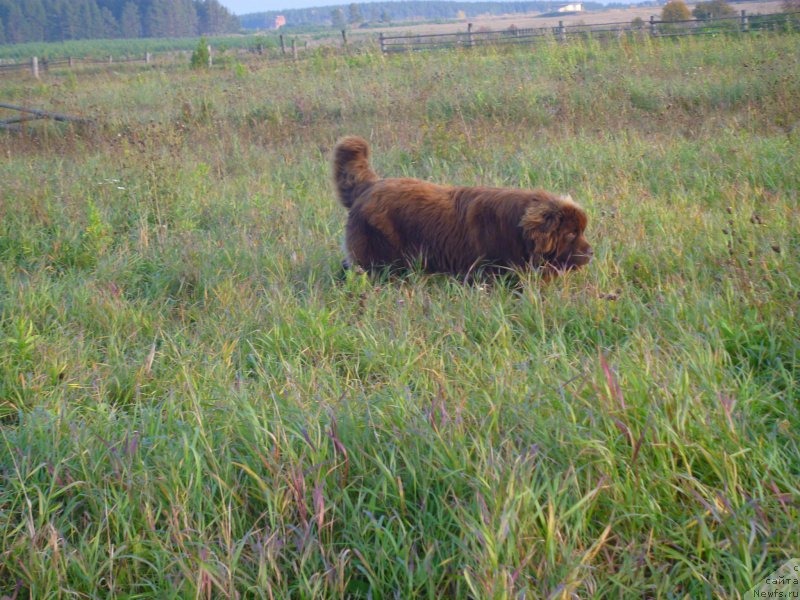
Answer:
239;0;603;29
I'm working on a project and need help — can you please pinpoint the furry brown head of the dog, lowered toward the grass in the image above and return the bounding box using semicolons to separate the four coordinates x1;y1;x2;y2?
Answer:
520;196;593;271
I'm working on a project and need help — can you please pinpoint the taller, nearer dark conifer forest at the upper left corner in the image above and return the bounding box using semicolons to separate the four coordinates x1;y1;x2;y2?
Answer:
0;0;240;44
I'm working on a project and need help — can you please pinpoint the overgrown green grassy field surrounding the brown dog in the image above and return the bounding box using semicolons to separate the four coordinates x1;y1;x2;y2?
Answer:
0;35;800;598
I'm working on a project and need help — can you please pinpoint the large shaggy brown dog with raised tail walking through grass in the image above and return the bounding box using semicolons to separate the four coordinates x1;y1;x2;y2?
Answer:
333;136;592;275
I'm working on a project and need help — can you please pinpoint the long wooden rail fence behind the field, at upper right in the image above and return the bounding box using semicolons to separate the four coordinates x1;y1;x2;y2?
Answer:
378;11;800;53
